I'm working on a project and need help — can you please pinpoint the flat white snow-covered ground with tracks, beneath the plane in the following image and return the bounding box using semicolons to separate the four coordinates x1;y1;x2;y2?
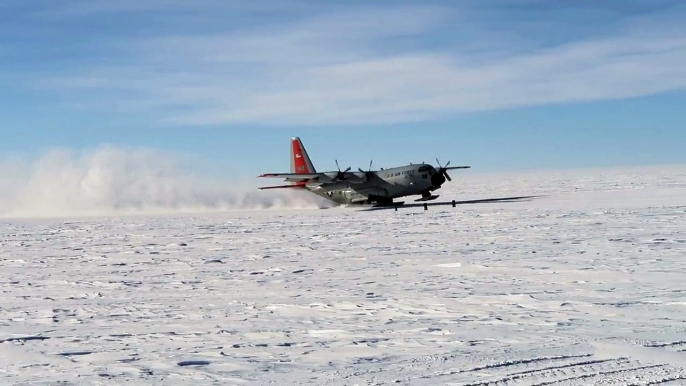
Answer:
0;167;686;385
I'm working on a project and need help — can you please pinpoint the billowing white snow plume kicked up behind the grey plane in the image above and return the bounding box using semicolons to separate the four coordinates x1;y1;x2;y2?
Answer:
0;147;334;217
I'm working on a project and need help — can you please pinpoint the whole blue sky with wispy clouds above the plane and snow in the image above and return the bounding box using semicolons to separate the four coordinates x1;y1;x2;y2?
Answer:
0;0;686;176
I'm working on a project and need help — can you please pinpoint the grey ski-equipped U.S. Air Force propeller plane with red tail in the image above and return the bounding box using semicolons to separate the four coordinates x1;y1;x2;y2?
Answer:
258;137;471;206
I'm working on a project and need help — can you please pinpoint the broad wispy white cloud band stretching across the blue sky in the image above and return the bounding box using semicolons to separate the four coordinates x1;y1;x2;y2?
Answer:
36;1;686;125
